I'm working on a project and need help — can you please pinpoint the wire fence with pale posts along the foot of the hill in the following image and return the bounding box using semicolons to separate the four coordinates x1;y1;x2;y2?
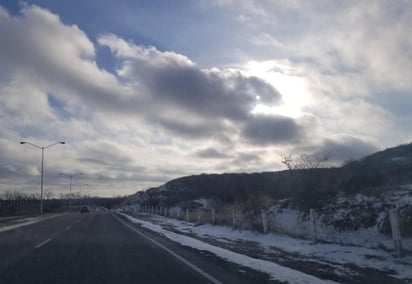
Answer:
130;205;412;257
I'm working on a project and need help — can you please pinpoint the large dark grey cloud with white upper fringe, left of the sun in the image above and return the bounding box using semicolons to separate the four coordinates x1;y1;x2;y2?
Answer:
99;35;281;121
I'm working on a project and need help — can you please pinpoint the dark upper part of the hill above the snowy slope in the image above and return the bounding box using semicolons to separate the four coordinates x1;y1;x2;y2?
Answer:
129;144;412;208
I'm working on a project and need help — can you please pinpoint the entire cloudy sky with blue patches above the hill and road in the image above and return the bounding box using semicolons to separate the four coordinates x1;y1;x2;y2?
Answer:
0;0;412;196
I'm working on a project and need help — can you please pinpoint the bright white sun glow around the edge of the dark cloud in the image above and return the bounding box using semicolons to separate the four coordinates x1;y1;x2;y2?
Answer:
242;61;310;118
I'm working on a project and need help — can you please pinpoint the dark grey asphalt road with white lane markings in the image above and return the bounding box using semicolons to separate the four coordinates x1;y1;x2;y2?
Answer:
0;212;267;284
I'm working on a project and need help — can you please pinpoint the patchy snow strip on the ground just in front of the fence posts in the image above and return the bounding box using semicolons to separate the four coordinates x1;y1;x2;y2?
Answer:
120;212;412;279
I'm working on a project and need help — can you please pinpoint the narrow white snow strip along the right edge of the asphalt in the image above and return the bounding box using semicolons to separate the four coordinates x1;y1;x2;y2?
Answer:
120;213;336;283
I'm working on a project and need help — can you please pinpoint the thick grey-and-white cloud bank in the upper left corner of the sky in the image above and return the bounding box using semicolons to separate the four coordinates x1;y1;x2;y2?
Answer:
0;6;131;122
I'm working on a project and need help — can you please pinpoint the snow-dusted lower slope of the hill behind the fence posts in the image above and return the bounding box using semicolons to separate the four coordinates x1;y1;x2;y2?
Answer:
120;189;412;253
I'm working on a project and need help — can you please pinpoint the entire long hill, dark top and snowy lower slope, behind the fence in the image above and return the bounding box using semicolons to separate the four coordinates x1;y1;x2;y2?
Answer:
125;144;412;246
